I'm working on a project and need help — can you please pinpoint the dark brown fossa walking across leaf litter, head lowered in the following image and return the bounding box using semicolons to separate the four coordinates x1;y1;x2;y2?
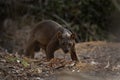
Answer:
25;20;78;60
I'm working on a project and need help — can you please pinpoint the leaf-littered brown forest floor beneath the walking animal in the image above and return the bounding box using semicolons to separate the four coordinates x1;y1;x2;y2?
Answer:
0;41;120;80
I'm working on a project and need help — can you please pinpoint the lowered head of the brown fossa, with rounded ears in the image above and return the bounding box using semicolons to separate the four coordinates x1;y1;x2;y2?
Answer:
57;31;75;53
